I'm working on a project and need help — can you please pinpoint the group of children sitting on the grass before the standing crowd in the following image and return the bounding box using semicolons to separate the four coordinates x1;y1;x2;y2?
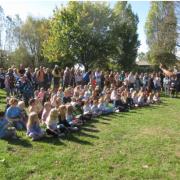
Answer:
0;85;160;140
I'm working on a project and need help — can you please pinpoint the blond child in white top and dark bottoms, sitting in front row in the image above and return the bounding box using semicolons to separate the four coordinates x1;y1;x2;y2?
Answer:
46;108;64;137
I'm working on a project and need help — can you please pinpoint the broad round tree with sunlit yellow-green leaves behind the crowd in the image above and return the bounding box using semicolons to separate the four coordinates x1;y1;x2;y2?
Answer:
43;2;110;68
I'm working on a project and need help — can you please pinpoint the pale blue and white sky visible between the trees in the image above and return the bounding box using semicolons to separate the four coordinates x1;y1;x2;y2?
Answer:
0;0;150;52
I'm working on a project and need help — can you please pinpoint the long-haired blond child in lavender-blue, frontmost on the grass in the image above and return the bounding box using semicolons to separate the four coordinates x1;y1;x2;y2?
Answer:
27;112;45;141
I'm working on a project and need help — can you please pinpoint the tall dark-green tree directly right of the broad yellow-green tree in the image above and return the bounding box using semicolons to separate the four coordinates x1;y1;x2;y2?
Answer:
111;2;140;69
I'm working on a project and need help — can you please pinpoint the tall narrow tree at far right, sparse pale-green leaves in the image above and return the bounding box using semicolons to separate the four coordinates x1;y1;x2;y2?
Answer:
145;1;177;65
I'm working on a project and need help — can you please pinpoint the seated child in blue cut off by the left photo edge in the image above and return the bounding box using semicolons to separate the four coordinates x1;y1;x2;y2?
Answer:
0;111;17;139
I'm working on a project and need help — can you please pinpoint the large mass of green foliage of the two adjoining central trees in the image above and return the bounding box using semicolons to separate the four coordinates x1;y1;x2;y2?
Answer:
43;2;139;68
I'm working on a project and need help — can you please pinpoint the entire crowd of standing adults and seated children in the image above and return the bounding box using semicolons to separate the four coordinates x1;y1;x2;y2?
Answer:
0;65;179;140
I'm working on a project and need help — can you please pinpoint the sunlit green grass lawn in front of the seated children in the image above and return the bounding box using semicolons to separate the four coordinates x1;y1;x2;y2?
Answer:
0;91;180;180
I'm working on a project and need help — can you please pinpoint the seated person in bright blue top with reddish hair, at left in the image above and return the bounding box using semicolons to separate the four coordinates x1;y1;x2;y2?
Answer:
6;98;23;130
